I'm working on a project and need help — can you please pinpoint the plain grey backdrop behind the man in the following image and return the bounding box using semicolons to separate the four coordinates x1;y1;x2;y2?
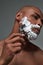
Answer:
0;0;43;49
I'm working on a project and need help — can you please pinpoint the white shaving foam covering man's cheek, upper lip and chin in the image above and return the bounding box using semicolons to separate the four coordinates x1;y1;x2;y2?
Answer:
20;17;40;40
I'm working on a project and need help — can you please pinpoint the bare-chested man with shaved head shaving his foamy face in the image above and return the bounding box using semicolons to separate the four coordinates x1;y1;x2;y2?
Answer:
0;6;43;65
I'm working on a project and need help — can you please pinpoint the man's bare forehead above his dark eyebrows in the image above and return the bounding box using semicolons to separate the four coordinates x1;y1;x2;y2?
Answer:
21;7;43;18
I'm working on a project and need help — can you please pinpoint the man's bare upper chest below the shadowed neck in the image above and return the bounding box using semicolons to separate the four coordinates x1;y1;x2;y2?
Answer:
9;51;43;65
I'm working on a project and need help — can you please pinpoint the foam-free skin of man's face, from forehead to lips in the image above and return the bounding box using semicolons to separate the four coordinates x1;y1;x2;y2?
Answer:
24;8;43;33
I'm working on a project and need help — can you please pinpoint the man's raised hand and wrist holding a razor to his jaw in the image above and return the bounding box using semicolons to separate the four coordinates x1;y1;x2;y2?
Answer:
1;33;25;65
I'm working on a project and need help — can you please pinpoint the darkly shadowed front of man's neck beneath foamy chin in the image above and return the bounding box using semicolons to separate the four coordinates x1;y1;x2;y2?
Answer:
23;40;41;52
